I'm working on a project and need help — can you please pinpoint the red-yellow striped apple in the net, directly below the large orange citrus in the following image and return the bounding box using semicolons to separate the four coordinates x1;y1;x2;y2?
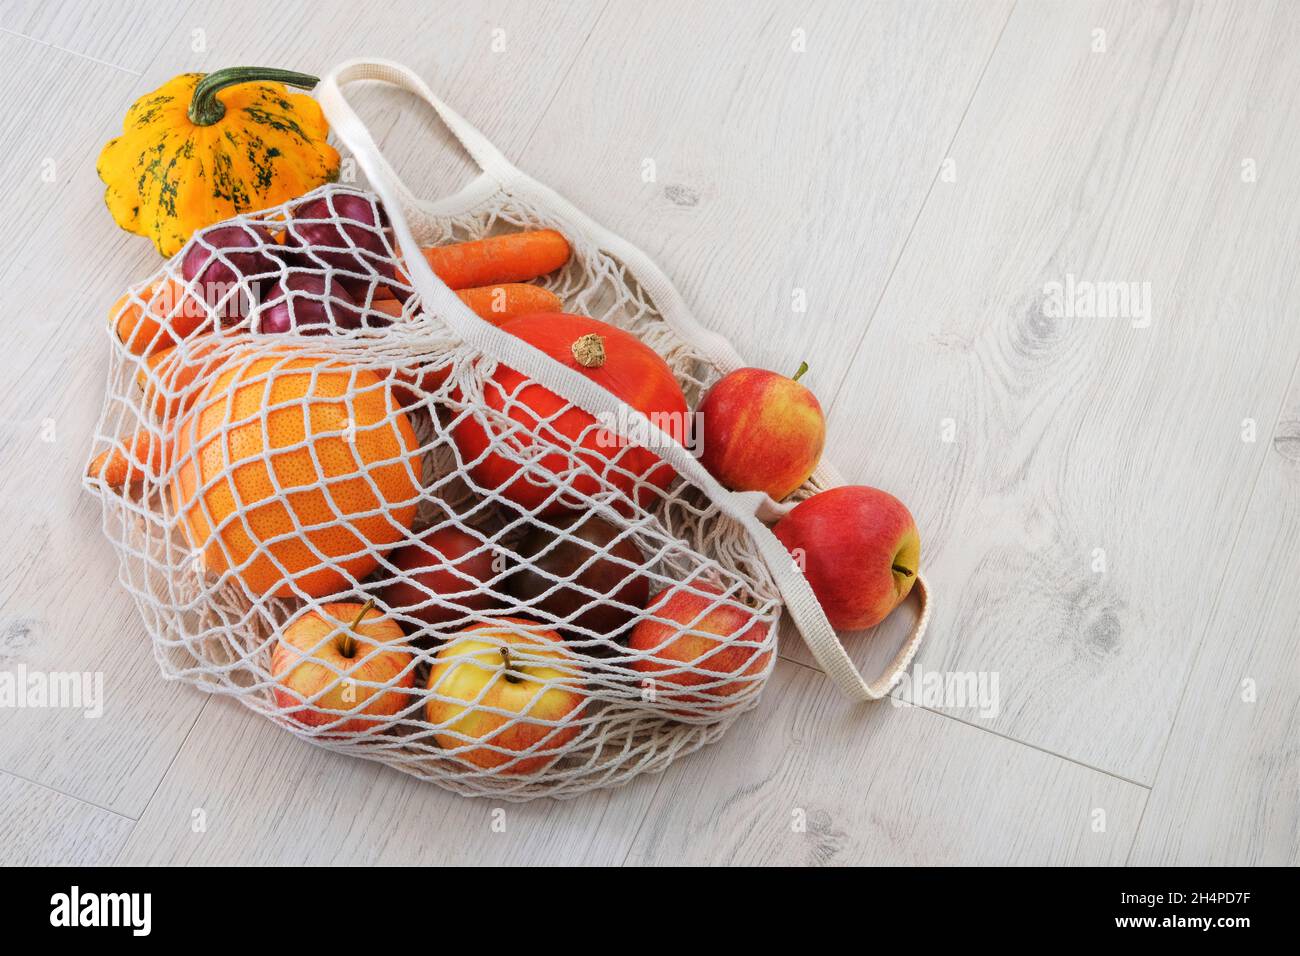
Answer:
270;601;415;734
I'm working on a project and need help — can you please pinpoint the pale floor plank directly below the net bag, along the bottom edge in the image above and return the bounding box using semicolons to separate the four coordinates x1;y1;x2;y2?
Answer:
120;698;659;866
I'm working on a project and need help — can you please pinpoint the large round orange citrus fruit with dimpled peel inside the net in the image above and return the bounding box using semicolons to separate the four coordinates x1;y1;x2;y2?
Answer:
172;349;420;597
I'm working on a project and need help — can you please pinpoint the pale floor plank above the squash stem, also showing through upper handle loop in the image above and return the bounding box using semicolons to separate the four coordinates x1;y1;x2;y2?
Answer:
146;0;606;204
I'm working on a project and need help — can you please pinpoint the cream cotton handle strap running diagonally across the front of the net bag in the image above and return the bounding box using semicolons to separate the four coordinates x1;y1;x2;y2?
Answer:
316;60;930;700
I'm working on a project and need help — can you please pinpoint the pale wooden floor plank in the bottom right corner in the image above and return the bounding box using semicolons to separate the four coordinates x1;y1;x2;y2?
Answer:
1131;382;1300;866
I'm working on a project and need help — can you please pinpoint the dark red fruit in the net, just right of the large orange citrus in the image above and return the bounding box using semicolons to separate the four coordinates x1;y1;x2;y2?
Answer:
382;525;506;627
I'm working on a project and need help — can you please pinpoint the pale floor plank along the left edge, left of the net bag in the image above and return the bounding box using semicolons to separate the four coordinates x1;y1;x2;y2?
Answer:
0;34;213;816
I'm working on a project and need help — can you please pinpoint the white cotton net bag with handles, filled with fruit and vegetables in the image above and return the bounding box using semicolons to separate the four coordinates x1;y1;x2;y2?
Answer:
87;61;928;800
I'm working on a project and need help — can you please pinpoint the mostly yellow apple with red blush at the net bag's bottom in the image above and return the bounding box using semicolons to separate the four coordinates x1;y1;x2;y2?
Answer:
425;618;586;774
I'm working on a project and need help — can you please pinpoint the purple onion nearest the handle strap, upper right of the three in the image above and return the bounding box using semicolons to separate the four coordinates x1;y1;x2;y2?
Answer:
287;193;410;300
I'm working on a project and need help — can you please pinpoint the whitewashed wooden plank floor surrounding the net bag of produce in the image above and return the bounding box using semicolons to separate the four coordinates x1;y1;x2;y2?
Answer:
0;0;1300;864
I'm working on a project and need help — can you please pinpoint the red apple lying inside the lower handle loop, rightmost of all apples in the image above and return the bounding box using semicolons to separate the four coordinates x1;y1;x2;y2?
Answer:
772;485;920;631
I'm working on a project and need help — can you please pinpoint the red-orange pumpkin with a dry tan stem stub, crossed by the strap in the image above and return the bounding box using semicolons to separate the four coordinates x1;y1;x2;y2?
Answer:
452;312;688;515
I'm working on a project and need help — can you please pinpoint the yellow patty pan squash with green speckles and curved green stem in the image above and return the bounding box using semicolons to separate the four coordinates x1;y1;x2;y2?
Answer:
95;66;338;256
